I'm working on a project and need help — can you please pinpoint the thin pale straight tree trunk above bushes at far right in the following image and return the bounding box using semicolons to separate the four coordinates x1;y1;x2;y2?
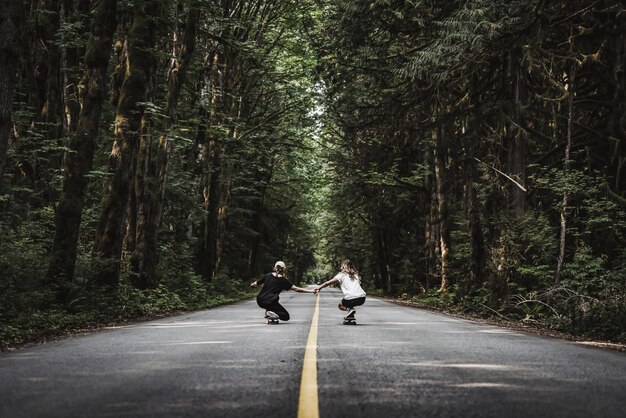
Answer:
554;60;576;286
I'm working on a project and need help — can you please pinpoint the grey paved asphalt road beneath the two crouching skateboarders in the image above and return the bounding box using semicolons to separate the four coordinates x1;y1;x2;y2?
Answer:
0;289;626;418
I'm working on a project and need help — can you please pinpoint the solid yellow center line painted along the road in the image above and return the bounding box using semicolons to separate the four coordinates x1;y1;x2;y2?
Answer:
298;295;320;418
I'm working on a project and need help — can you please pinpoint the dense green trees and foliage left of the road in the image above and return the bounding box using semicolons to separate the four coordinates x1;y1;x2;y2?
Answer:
0;0;316;347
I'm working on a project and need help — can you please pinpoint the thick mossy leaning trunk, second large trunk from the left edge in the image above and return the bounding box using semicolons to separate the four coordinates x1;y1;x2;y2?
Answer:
47;0;117;299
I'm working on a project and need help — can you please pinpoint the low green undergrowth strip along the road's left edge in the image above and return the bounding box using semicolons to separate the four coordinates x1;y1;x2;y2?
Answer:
0;280;256;351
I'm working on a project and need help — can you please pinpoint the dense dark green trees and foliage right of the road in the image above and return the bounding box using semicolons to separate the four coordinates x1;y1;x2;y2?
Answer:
317;0;626;341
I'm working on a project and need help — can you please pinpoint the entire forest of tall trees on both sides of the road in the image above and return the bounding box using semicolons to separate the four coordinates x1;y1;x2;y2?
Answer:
0;0;626;349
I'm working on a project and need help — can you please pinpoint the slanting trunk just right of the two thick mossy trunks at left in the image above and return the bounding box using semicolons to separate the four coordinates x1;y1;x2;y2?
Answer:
132;8;200;289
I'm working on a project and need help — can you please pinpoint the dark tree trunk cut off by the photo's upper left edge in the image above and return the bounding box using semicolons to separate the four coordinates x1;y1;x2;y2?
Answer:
0;0;24;188
